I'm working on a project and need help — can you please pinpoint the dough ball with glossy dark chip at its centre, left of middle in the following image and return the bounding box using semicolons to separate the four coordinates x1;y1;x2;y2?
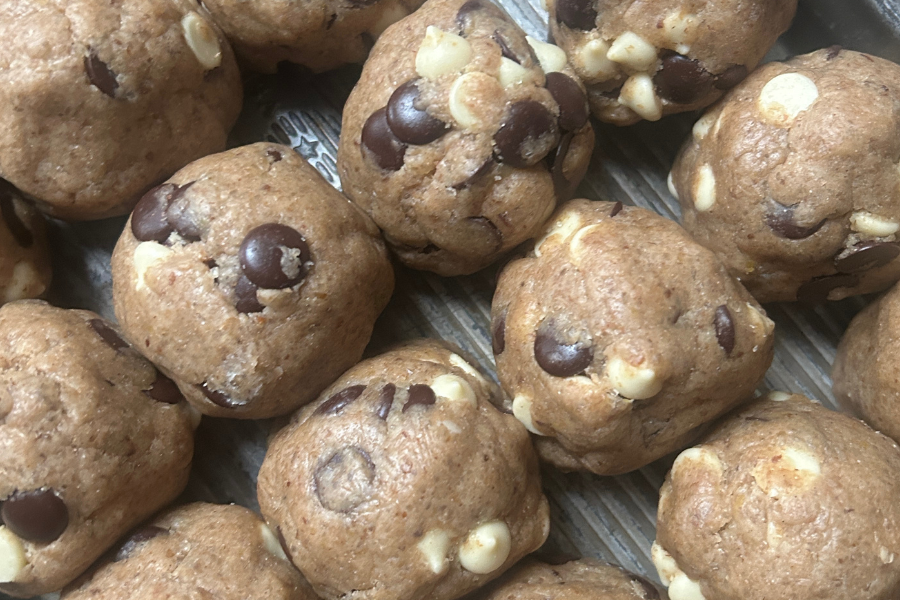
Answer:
112;143;394;419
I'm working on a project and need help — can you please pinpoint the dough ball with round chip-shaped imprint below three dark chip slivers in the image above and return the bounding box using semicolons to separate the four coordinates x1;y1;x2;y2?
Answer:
258;340;550;600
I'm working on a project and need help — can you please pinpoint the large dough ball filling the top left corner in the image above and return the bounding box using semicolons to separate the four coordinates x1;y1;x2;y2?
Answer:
0;0;242;220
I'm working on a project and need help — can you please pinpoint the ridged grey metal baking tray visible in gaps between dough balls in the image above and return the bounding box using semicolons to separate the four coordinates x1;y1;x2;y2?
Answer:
24;0;900;598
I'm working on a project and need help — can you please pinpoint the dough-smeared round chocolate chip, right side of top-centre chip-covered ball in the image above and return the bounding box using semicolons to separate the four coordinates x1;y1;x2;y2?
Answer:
494;100;557;169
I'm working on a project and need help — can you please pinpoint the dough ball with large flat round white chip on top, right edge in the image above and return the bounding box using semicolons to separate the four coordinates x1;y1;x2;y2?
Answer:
670;47;900;303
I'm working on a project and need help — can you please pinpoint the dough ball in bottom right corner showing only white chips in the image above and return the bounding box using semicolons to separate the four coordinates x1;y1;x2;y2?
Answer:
651;392;900;600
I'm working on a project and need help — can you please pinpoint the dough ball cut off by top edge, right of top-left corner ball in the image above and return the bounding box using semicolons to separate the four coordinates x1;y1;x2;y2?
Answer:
203;0;422;73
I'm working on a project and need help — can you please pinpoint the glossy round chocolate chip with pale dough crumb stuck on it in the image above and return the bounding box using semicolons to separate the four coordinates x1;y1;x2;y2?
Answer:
239;223;310;289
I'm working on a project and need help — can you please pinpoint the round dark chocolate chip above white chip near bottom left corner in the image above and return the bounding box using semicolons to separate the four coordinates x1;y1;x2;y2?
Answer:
0;488;69;544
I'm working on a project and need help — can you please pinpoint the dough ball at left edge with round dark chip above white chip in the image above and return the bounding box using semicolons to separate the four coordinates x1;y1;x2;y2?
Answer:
0;300;198;597
